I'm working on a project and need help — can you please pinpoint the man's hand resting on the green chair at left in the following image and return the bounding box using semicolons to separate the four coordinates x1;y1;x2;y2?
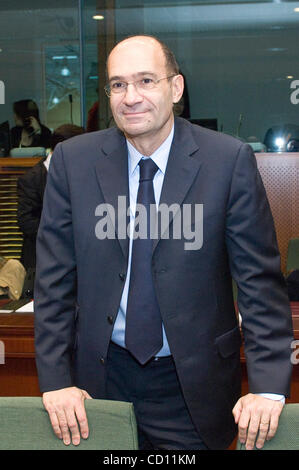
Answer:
43;387;91;445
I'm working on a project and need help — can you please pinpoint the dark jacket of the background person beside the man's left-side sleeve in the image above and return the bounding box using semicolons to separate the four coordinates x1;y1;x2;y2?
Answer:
17;159;48;269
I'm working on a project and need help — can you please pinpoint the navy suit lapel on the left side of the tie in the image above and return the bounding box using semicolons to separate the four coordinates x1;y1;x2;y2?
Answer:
95;129;129;259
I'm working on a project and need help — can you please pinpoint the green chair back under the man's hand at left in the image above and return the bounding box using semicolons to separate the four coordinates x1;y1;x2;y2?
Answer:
0;397;138;450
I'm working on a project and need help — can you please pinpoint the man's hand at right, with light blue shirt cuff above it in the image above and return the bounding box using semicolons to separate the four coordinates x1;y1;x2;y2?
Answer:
233;393;283;450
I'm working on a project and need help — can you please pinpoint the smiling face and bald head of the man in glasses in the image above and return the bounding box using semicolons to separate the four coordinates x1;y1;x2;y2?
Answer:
108;37;183;143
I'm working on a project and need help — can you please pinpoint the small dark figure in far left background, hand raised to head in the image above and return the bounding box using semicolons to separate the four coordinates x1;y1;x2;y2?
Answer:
11;100;52;148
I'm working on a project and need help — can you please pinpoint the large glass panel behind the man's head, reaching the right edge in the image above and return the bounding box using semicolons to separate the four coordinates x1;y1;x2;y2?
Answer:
86;0;299;152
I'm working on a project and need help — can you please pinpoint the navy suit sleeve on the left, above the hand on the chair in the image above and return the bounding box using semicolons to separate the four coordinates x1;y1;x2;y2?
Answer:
34;144;76;392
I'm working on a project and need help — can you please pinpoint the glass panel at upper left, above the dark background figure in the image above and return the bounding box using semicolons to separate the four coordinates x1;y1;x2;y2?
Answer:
0;0;81;150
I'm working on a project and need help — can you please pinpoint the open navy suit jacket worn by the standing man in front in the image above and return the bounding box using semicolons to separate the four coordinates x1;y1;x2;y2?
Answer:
35;118;292;449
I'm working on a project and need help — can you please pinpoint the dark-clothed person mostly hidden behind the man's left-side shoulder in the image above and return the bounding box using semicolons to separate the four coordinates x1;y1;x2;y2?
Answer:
17;124;85;270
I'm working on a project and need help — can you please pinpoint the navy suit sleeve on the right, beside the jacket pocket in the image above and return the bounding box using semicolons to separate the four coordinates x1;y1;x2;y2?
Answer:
226;144;293;396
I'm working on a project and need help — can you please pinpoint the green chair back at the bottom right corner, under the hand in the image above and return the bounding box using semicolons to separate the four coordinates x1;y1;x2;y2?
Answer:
236;403;299;450
